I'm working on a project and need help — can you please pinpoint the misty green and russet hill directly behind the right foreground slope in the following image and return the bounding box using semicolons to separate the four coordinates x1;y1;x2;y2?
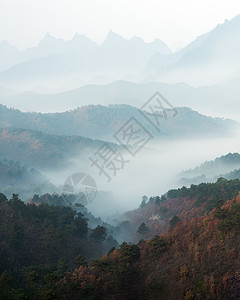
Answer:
124;178;240;242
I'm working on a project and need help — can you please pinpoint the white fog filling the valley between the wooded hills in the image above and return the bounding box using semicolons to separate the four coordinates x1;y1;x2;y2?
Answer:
40;136;240;221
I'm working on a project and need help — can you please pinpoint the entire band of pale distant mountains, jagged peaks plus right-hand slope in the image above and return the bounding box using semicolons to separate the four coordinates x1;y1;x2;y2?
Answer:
0;16;240;92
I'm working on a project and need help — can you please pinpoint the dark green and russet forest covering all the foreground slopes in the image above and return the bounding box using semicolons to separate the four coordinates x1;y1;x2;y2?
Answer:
0;178;240;300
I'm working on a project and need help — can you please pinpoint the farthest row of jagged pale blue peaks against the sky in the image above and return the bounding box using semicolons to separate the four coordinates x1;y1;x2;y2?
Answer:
0;30;171;70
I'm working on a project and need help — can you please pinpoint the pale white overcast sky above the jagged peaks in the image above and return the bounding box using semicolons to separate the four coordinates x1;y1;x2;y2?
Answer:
0;0;240;49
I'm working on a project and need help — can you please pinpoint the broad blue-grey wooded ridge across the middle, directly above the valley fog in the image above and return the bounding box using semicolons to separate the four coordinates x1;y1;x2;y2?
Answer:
0;105;239;141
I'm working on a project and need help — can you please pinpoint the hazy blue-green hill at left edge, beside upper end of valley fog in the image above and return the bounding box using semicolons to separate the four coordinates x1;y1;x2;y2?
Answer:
0;128;115;170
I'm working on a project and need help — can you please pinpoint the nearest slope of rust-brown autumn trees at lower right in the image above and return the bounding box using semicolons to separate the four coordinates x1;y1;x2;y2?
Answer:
56;196;240;300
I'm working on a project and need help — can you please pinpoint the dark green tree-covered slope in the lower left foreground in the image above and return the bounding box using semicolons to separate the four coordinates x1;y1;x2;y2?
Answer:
0;194;117;300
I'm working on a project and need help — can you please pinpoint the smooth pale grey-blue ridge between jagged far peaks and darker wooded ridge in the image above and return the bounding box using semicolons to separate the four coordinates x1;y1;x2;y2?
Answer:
0;80;192;112
